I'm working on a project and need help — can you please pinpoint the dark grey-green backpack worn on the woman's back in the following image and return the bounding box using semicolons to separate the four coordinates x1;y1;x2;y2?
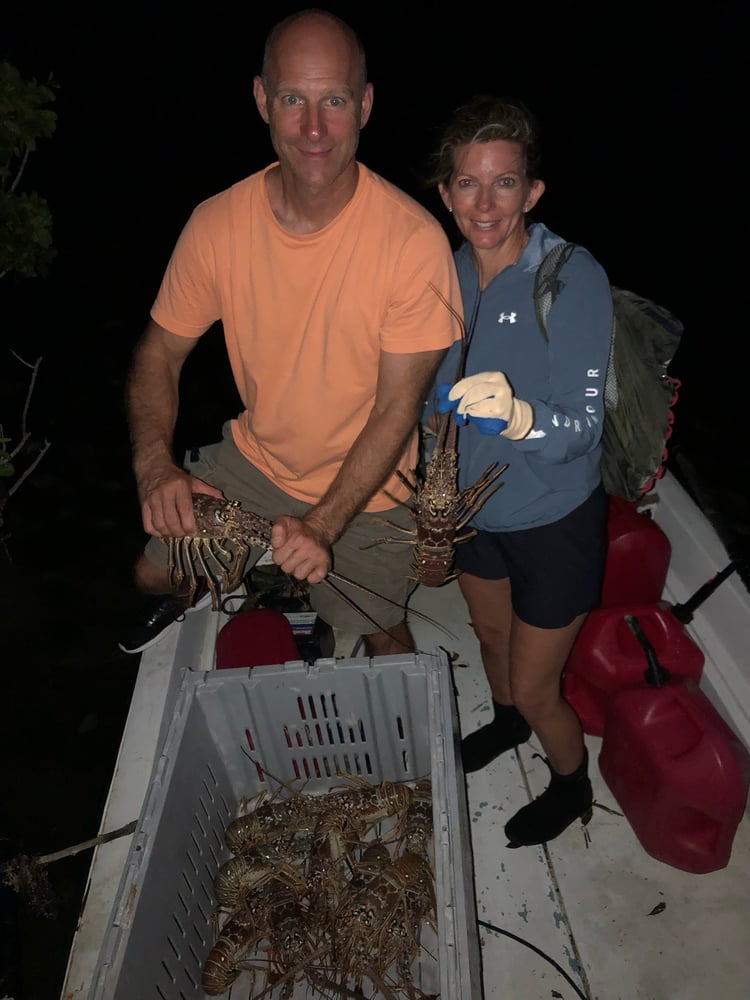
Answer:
534;243;683;500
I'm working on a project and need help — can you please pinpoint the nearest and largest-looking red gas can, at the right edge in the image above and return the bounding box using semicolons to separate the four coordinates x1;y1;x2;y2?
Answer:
599;680;750;874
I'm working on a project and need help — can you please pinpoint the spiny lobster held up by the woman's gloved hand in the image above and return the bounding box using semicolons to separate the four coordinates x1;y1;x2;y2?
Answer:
368;283;508;587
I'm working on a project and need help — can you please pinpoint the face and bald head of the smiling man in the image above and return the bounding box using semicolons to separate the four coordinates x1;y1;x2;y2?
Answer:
254;22;372;191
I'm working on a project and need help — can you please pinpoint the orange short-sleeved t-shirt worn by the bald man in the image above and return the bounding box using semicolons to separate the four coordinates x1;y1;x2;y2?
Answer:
151;164;460;510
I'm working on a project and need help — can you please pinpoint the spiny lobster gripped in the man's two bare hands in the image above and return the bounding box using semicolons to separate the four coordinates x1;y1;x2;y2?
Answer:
162;493;450;634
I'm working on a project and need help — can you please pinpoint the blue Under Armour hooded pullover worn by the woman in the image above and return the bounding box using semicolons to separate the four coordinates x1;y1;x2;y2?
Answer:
427;223;613;531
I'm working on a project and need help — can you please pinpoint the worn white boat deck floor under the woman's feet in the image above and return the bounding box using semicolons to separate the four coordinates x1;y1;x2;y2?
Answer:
412;584;750;1000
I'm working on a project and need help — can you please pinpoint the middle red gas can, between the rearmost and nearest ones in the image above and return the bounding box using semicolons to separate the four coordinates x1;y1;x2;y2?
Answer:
562;601;704;736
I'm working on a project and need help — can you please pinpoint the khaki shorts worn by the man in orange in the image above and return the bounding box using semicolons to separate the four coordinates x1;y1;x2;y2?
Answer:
145;422;415;635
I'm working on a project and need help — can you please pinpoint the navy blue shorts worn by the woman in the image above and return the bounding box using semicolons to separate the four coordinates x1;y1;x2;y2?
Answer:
456;486;608;628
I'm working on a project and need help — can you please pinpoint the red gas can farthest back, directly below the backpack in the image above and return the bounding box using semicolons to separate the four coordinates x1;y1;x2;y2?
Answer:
600;496;672;608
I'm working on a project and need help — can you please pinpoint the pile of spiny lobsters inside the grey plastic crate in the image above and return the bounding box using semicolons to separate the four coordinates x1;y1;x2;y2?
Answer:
201;777;438;1000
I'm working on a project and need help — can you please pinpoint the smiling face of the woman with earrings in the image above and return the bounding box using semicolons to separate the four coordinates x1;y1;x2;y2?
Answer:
439;139;544;251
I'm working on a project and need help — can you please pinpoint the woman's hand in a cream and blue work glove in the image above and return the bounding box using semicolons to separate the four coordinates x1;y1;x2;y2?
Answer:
440;372;534;441
